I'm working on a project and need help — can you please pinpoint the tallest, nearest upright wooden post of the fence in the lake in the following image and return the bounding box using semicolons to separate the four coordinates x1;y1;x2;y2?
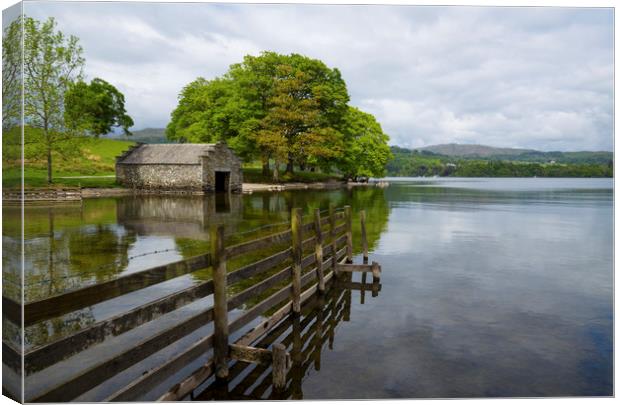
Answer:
211;225;228;379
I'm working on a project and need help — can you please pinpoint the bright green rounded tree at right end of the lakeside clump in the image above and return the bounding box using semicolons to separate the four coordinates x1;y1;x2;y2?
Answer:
339;107;393;179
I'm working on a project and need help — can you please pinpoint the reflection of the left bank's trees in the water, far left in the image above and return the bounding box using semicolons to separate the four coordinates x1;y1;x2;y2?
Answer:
24;204;136;346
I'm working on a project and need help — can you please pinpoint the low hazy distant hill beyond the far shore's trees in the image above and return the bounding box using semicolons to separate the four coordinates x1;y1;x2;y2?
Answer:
417;143;613;164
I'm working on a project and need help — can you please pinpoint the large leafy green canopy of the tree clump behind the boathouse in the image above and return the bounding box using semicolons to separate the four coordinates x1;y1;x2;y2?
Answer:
166;52;389;180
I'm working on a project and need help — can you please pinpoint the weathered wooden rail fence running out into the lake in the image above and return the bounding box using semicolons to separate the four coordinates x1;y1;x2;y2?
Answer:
3;206;380;402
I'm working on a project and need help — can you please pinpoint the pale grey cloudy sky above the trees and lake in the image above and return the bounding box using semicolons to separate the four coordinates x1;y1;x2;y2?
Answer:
24;2;613;150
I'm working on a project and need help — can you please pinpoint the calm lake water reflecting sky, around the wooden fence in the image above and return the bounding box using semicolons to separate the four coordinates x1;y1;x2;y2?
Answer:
3;179;613;400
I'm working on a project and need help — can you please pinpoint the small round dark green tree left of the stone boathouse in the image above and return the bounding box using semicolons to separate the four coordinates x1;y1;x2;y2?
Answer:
65;78;133;136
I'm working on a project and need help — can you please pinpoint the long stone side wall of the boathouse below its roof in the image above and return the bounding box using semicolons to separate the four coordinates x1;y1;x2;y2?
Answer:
116;164;203;190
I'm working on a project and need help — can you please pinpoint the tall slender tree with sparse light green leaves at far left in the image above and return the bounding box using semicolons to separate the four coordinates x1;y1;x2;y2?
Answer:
23;17;84;183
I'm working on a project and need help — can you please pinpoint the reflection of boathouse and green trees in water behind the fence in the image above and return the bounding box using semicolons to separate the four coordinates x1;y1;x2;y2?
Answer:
13;185;388;347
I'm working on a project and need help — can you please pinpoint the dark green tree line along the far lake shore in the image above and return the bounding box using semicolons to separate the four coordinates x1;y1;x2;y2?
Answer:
386;147;613;177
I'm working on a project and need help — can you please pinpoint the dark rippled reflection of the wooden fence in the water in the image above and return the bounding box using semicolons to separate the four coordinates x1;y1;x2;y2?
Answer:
193;273;380;401
